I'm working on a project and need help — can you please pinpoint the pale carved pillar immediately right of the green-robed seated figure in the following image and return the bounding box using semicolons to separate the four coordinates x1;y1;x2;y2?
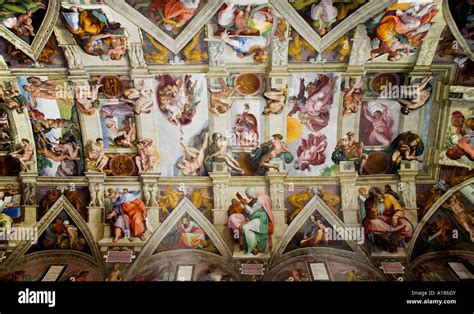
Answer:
266;171;288;247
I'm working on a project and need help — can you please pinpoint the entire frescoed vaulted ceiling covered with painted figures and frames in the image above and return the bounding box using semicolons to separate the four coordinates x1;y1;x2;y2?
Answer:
0;0;474;298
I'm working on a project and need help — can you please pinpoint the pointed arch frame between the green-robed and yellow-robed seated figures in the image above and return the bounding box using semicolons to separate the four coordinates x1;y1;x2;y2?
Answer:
270;195;371;265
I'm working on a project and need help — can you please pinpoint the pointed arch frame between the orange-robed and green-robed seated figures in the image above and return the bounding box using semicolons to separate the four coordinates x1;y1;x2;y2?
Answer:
128;198;237;273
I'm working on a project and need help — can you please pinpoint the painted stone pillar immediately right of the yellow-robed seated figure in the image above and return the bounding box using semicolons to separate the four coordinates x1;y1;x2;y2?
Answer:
398;160;418;227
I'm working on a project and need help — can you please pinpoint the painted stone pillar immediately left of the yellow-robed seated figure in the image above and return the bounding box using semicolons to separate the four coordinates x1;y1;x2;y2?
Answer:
337;161;359;227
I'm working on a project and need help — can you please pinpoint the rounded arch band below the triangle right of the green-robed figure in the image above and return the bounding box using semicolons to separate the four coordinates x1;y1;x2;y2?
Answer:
263;247;387;281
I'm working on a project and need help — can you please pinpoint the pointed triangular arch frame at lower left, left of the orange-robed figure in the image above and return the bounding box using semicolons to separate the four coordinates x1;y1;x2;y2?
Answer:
5;195;105;273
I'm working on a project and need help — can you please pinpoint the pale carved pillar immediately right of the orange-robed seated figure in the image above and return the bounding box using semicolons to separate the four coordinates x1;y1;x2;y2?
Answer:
140;172;160;232
